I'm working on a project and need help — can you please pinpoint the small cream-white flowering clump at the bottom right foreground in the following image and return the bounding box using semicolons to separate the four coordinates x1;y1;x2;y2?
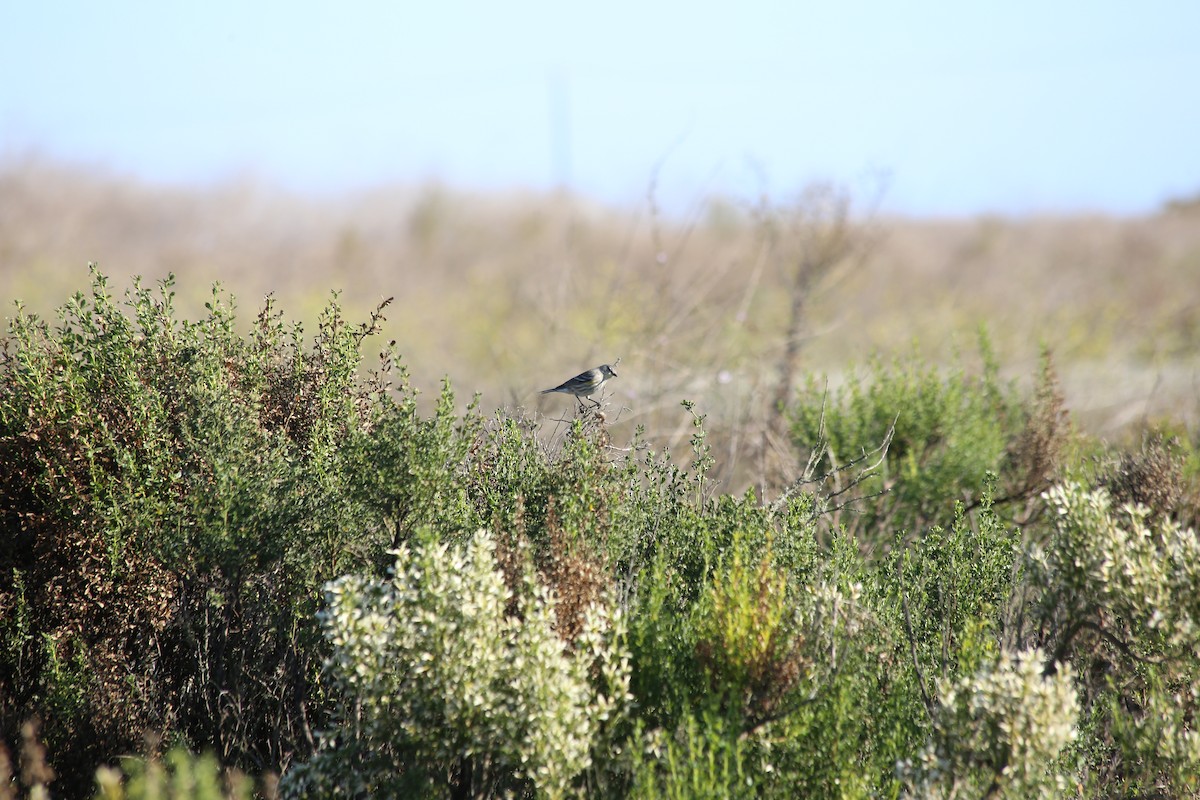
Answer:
896;649;1079;799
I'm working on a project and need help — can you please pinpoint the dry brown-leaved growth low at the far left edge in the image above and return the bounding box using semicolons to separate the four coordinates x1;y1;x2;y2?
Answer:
0;432;178;787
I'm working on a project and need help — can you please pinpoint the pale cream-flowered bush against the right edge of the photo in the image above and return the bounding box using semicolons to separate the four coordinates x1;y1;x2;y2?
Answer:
1026;485;1200;794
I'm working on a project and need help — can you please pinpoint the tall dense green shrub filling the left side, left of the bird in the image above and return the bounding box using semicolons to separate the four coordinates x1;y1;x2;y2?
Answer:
0;270;451;794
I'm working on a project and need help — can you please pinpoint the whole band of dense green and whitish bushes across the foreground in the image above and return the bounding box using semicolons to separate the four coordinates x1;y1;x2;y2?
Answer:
0;273;1200;798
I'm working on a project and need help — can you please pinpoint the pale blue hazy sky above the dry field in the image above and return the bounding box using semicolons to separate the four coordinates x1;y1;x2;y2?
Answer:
0;0;1200;215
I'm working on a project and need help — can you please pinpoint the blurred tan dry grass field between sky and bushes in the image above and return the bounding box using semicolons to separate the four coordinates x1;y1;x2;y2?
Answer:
0;152;1200;482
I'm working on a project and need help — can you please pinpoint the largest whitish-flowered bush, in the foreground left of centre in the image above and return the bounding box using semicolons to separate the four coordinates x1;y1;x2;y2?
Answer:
282;531;629;798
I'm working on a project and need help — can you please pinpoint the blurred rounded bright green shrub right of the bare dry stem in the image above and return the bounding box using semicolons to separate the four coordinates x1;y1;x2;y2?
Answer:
788;336;1068;547
